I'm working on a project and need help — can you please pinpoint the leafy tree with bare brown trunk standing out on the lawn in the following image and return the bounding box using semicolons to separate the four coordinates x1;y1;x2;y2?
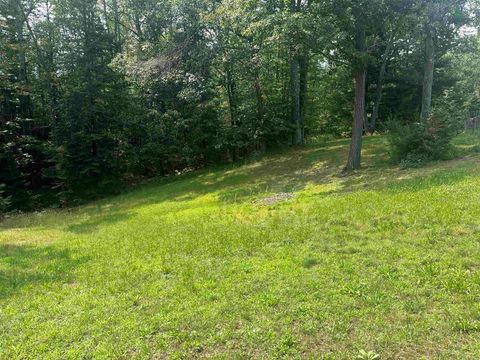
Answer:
329;0;411;171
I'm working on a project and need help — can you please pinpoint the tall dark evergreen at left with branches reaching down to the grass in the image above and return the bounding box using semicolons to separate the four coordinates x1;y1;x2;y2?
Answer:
54;0;133;197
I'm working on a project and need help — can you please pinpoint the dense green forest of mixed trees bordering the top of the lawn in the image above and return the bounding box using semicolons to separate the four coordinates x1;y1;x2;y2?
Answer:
0;0;480;210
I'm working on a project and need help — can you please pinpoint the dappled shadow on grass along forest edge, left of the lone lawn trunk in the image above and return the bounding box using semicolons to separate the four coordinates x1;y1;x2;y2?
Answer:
18;140;348;235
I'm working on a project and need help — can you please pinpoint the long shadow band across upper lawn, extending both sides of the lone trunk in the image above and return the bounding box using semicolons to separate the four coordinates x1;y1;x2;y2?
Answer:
0;136;478;234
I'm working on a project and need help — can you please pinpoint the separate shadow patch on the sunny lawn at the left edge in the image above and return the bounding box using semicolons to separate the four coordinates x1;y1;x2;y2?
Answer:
0;244;88;299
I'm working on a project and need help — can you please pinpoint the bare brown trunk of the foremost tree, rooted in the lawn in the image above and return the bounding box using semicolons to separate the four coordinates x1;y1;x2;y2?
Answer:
345;13;367;171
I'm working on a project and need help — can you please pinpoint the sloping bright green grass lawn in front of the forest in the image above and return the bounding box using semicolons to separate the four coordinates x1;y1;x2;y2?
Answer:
0;136;480;359
